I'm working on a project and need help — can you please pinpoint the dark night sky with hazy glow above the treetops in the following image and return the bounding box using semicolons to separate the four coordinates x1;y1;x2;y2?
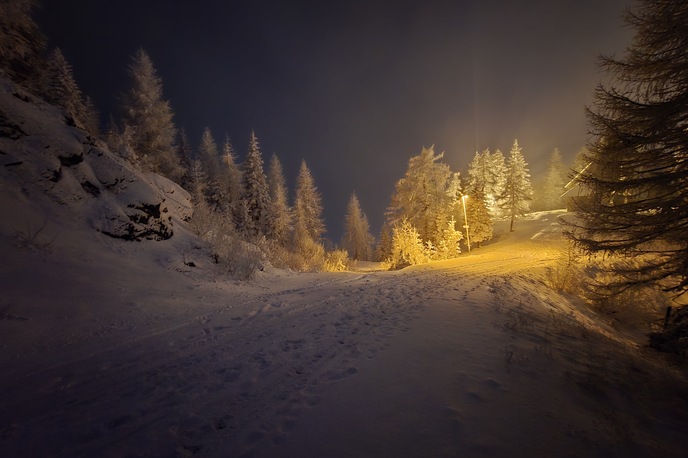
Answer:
34;0;634;242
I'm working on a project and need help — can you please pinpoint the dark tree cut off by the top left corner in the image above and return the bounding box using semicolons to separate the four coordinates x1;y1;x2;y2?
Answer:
0;0;46;92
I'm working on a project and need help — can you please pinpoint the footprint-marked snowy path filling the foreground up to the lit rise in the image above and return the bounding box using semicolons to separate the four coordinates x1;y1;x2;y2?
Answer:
0;213;688;458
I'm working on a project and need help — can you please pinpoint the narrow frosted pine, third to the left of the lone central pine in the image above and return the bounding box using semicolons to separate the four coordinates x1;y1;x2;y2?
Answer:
242;131;272;238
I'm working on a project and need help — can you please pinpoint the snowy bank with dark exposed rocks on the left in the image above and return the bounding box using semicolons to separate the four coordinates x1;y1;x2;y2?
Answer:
0;79;192;241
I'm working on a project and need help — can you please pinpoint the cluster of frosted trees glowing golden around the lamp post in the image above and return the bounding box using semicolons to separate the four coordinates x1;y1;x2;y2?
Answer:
377;141;540;267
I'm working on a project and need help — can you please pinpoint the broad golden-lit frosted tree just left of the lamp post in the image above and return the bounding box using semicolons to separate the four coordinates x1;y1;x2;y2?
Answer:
386;146;451;243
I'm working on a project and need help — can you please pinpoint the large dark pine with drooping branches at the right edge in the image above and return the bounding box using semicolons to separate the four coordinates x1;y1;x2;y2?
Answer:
568;0;688;293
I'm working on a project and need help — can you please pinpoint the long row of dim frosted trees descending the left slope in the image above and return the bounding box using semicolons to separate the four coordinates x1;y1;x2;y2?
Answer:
0;0;373;268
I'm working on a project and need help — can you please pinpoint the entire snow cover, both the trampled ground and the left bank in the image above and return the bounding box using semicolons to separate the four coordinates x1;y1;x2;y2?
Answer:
0;77;688;458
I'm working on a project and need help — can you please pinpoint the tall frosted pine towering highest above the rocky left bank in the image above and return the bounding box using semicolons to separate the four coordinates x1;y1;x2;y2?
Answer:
122;49;183;181
